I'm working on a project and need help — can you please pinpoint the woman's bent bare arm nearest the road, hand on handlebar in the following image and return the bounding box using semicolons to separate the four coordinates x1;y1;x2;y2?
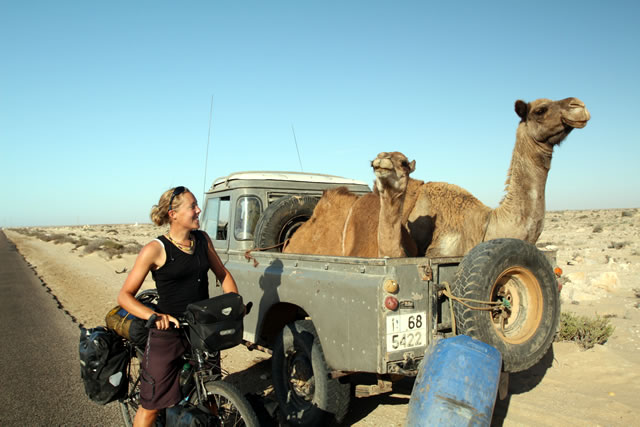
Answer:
118;242;180;329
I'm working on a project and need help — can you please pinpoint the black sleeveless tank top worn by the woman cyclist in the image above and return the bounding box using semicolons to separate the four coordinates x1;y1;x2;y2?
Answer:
151;230;209;317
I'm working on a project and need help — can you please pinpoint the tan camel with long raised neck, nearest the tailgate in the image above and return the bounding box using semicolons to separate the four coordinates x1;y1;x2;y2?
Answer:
406;98;591;257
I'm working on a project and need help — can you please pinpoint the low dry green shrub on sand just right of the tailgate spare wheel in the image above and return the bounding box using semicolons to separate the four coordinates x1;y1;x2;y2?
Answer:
556;313;615;350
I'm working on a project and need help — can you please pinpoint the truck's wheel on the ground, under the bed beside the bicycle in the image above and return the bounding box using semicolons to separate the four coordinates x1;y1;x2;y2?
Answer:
271;320;350;426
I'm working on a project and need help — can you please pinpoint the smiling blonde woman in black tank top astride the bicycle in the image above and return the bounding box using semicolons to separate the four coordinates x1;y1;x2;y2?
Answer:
118;186;238;426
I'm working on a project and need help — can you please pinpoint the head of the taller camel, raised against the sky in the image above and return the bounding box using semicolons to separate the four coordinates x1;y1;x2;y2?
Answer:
515;98;591;148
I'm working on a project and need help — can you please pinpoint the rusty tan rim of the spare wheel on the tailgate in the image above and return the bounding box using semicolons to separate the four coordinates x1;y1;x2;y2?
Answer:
491;267;543;344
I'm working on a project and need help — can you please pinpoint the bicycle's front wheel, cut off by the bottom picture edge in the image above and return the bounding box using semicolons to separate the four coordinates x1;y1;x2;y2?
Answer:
199;381;260;427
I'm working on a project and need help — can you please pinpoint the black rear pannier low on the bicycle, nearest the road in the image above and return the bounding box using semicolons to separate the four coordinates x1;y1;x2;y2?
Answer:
79;326;129;405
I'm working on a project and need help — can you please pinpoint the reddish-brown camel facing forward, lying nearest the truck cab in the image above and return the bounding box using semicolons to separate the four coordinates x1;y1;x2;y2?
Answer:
283;152;422;258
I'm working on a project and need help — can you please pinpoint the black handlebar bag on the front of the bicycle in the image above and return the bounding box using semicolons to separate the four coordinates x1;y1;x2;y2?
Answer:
186;293;244;352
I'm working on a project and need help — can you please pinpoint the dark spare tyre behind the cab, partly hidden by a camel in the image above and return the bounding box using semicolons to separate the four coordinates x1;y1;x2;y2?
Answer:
254;196;318;252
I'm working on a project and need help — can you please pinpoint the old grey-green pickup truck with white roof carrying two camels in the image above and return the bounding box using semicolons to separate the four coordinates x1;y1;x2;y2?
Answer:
202;172;559;425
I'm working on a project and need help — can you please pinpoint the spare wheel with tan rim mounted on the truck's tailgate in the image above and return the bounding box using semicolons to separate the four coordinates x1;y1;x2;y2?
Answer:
451;239;560;372
